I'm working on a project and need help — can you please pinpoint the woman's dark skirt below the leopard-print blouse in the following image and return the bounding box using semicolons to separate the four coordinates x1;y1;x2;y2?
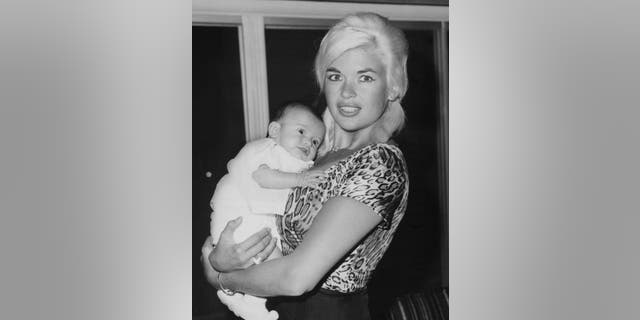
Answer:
268;289;371;320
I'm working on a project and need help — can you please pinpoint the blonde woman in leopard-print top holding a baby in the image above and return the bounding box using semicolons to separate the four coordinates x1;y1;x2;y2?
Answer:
202;13;409;320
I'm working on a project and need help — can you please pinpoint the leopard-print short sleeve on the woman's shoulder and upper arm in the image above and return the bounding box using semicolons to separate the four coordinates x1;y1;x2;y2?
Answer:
339;145;408;229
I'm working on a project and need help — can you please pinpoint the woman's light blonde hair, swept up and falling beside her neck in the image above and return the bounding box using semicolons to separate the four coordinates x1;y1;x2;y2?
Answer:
314;12;409;154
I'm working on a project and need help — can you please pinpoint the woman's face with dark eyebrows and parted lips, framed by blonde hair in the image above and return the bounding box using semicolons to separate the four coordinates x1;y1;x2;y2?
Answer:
324;48;387;132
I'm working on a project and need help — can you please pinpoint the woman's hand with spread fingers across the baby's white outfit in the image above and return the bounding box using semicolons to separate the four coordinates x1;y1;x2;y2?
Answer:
202;217;276;272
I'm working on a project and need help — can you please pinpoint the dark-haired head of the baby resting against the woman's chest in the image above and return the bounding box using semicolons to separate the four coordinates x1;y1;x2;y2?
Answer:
269;102;324;161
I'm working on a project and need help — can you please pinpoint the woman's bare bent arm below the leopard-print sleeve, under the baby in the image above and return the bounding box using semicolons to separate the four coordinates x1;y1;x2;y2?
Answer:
210;197;382;296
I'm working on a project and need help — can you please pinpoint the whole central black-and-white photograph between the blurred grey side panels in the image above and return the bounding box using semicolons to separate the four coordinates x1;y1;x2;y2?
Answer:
192;1;449;320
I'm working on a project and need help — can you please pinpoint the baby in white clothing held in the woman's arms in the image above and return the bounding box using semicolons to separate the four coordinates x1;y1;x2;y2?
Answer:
211;103;325;320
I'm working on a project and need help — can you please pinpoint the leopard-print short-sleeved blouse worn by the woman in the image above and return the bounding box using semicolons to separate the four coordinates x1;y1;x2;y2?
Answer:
276;143;409;293
